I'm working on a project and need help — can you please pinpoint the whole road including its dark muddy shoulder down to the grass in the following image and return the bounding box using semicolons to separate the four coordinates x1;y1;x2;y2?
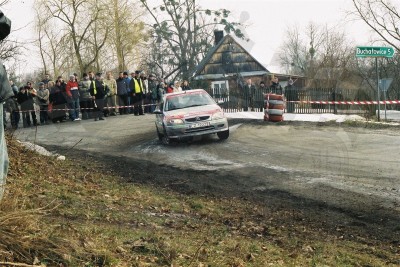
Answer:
14;115;400;244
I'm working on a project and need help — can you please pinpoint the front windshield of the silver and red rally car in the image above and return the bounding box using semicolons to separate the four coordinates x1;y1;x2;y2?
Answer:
165;93;215;111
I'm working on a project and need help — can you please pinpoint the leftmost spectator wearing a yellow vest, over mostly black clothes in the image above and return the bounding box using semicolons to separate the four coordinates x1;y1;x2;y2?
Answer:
90;72;108;121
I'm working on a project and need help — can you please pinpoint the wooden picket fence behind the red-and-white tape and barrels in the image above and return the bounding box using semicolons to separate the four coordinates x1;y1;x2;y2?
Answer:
207;88;376;114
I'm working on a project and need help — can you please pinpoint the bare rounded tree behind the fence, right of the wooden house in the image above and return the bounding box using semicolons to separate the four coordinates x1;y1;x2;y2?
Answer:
280;23;353;87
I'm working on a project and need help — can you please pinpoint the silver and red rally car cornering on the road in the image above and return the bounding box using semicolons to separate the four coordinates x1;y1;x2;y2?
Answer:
154;89;229;144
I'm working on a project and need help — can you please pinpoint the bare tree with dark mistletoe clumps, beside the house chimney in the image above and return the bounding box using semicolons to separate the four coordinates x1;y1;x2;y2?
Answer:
141;0;243;79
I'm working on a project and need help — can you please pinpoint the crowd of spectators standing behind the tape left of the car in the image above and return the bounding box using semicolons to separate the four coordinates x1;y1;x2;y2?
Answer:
4;71;191;129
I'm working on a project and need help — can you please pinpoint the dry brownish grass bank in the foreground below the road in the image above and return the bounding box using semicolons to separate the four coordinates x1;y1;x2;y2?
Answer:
0;135;399;267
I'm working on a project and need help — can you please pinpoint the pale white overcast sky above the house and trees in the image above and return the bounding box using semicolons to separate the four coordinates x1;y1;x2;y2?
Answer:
3;0;370;75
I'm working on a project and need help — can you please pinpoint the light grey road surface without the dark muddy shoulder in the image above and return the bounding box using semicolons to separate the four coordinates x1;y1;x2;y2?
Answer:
14;115;400;221
